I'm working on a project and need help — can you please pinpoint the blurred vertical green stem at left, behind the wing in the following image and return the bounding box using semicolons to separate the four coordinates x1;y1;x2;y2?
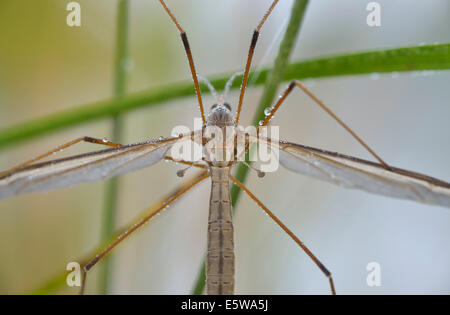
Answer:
99;0;128;294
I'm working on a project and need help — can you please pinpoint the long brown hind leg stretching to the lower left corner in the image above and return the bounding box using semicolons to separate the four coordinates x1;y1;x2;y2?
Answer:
80;172;210;294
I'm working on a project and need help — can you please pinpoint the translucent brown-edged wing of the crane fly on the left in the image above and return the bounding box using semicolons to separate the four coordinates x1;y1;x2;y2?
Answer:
0;138;187;199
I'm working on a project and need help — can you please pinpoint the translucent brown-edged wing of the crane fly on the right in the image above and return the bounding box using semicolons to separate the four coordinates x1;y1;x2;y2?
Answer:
255;138;450;207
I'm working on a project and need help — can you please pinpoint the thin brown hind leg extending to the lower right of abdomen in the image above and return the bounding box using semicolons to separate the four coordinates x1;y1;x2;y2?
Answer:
230;176;336;295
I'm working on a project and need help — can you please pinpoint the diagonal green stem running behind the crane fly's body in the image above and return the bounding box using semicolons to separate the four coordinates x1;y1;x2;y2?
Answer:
193;0;308;294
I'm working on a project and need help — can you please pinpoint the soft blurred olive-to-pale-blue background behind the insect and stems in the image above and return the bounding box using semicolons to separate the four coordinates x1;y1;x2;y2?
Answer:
0;0;450;294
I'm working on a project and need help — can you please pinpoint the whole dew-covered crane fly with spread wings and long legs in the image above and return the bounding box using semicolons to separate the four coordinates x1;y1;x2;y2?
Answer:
0;0;450;294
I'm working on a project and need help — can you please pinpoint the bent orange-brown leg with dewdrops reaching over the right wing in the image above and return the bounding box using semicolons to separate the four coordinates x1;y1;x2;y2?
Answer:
261;80;391;170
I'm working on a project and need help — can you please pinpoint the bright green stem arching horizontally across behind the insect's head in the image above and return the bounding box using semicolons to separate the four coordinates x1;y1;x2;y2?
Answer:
0;43;450;149
